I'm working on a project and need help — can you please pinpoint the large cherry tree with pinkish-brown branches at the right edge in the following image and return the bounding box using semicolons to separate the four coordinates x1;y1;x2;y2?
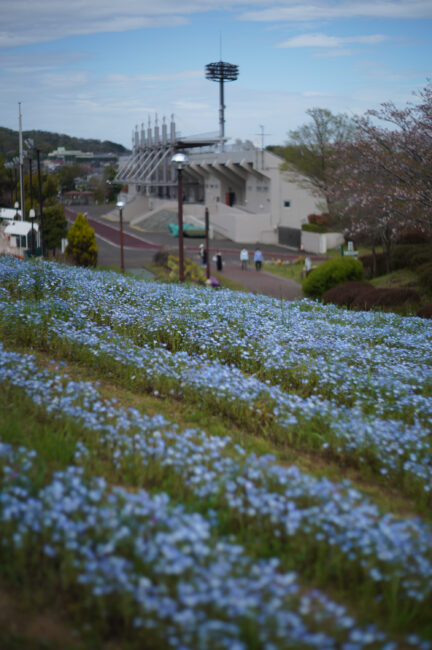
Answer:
329;79;432;270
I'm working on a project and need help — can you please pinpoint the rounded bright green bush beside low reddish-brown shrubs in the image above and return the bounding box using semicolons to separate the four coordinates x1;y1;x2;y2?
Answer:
302;257;364;298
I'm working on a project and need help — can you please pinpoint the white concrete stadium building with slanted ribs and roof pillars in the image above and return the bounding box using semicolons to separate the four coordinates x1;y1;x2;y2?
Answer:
116;116;324;248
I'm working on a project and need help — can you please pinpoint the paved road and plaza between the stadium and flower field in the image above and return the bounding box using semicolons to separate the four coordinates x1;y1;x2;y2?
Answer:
65;206;303;300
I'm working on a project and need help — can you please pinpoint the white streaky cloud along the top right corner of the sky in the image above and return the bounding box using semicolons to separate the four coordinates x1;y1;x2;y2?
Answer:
240;0;432;23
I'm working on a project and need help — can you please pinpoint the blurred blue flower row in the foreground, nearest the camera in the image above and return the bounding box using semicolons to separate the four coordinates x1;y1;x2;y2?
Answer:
4;438;404;650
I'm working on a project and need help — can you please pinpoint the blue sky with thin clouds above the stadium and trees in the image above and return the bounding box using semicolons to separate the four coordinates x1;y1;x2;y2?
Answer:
0;0;432;148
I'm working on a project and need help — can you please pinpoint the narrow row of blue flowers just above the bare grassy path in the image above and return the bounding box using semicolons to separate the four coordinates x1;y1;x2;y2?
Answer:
3;282;432;492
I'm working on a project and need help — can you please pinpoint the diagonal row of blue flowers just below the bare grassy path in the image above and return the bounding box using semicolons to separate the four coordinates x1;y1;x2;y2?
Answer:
0;342;432;620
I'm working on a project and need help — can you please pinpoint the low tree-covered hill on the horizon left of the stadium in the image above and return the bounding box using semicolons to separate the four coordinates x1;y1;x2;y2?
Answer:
0;126;128;159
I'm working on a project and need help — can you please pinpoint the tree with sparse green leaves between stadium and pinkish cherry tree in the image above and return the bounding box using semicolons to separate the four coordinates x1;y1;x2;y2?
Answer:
282;108;355;213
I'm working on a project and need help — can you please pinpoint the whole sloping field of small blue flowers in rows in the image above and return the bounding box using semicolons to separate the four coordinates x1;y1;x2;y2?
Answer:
0;257;432;650
